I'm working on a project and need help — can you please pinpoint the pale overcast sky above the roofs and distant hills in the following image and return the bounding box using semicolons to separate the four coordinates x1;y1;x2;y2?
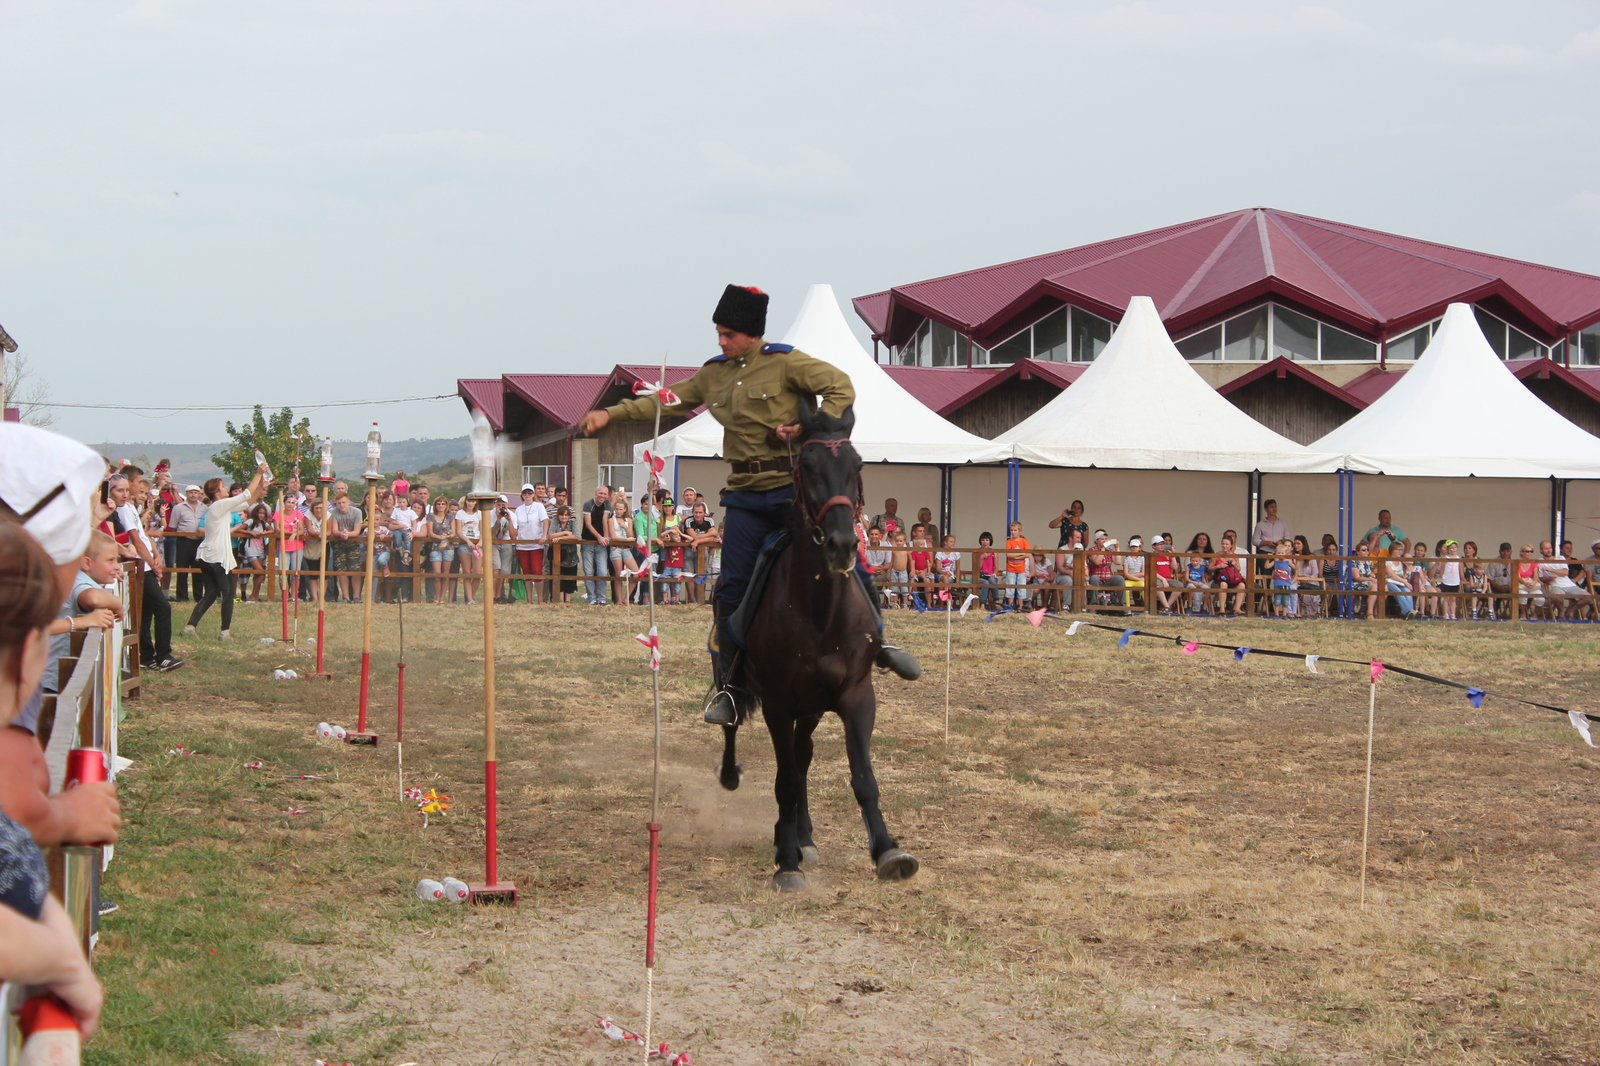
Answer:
0;0;1600;442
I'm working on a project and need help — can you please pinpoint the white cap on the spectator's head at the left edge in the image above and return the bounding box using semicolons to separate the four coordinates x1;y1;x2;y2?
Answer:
0;423;106;563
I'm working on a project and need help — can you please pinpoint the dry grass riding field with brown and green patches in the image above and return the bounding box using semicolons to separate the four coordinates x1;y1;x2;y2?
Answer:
91;592;1600;1066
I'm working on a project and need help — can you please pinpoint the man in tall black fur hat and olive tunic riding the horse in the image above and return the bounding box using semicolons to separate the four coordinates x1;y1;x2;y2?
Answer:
578;285;922;725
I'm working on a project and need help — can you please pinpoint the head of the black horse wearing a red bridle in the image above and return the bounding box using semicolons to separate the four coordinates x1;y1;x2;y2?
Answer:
795;395;861;573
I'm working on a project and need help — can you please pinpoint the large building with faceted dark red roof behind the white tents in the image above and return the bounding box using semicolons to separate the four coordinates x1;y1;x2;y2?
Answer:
854;208;1600;443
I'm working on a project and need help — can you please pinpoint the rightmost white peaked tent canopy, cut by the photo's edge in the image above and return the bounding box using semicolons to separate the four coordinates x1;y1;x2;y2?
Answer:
1312;304;1600;479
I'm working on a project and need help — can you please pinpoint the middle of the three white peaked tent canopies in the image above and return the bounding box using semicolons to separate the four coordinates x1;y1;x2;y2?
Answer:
1005;296;1341;474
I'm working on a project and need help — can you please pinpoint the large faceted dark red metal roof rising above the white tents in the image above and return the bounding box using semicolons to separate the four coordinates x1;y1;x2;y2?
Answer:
854;208;1600;346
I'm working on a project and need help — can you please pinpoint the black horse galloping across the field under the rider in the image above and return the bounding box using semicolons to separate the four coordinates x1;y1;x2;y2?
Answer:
718;397;918;892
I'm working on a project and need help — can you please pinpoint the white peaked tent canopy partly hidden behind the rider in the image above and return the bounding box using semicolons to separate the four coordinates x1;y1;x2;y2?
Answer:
634;285;1011;466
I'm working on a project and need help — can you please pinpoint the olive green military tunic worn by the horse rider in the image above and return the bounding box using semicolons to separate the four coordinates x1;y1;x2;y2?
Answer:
605;344;856;491
